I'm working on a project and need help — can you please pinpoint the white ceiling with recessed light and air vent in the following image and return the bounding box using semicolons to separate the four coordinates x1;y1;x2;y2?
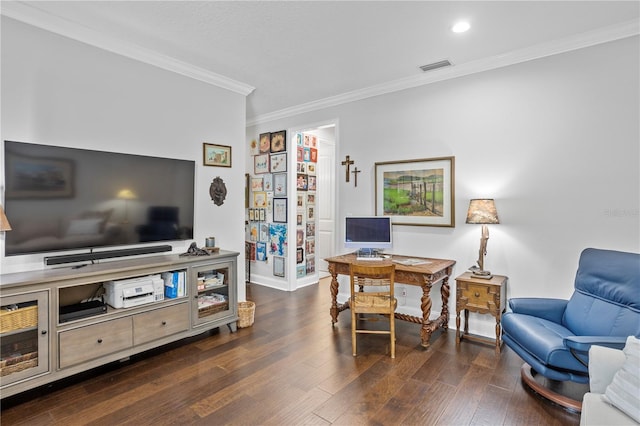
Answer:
2;1;640;122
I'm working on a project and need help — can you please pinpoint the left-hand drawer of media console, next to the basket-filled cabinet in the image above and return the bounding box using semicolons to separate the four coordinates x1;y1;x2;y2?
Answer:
59;318;133;368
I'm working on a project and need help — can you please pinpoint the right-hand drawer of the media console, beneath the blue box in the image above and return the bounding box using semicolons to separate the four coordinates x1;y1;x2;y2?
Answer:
133;303;189;345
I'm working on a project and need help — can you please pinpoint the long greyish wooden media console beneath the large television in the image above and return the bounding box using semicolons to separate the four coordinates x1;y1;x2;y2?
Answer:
0;250;238;398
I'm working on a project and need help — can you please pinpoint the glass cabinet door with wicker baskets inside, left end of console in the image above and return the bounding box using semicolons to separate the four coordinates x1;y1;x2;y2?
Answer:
0;291;49;386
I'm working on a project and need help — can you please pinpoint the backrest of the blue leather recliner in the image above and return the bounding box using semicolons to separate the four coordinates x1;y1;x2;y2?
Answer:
562;248;640;337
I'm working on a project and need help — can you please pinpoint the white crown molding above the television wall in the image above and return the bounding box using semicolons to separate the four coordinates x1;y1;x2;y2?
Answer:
0;1;255;96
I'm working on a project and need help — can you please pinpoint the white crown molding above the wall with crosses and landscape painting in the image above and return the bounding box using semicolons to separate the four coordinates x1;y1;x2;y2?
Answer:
247;19;640;126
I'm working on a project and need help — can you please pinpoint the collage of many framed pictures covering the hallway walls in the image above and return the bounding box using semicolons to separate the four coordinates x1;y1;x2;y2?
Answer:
245;130;318;277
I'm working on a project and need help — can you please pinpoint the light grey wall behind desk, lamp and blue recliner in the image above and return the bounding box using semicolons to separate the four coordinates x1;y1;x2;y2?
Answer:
247;37;640;335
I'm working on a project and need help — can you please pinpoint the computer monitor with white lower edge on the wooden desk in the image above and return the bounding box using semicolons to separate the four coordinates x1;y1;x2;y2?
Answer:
344;216;392;251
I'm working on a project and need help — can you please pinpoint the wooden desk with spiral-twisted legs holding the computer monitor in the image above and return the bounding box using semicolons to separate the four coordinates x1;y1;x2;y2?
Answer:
325;253;456;348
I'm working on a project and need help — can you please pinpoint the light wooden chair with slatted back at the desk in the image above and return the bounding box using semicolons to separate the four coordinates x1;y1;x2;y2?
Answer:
349;263;398;358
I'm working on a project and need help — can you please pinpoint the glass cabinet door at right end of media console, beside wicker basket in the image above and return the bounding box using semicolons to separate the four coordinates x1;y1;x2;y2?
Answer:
193;263;235;325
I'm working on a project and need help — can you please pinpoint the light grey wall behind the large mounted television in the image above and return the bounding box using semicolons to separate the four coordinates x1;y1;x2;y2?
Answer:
0;16;246;300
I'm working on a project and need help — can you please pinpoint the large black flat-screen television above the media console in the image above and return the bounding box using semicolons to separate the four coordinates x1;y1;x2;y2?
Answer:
4;141;195;256
